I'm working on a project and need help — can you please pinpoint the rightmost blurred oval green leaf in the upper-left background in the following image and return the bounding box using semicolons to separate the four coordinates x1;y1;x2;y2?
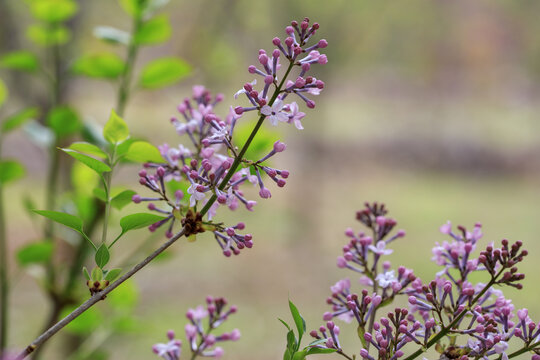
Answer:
139;58;191;89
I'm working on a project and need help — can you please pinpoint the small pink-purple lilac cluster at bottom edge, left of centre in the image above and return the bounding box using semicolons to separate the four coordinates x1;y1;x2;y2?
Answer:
152;296;240;360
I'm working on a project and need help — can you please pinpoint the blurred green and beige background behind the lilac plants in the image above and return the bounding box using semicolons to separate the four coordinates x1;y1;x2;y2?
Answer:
0;0;540;360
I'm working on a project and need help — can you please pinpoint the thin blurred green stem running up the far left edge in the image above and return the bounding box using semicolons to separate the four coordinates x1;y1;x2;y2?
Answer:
0;134;9;357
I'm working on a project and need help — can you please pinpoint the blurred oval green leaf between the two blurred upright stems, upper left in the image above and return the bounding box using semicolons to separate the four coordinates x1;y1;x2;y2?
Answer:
72;53;125;79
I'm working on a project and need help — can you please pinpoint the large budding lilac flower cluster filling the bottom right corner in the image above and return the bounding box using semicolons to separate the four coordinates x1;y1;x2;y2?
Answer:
311;203;540;360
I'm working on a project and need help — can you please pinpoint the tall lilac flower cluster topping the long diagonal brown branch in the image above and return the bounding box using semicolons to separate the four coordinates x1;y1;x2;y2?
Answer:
133;18;328;256
